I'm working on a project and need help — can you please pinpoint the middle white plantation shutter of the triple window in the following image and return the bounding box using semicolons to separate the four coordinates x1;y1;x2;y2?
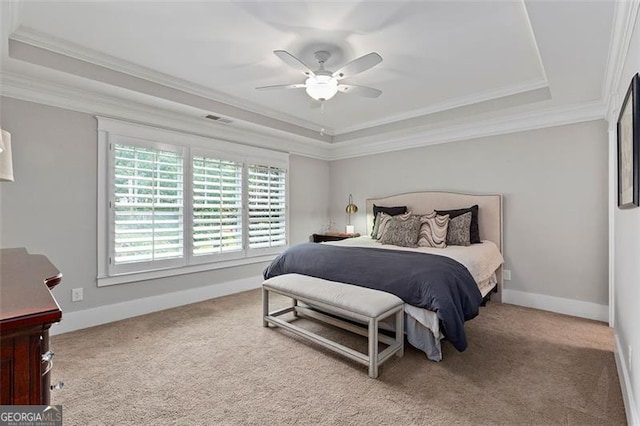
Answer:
193;156;242;256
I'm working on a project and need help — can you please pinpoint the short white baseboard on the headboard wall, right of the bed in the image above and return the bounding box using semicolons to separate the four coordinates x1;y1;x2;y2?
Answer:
502;289;609;323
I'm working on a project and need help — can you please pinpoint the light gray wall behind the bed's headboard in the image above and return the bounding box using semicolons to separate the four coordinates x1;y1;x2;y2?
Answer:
330;121;608;305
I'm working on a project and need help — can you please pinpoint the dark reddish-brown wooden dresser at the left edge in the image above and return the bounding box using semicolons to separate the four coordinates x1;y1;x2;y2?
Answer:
0;248;62;405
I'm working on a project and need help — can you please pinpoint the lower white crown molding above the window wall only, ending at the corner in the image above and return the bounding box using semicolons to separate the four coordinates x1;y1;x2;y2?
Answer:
0;72;330;160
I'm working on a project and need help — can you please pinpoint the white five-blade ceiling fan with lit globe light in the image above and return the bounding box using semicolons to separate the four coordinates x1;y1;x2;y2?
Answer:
256;50;382;101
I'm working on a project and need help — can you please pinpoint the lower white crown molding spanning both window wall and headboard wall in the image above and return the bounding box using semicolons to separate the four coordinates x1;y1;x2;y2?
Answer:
0;69;605;161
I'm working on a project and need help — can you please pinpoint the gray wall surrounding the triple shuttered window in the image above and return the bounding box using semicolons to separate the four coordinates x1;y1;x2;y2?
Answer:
0;98;329;312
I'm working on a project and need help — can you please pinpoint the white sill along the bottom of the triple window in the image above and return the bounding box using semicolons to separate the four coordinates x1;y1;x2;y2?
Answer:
98;254;277;287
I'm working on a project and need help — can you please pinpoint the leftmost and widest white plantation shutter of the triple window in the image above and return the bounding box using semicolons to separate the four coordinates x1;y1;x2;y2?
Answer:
112;144;184;266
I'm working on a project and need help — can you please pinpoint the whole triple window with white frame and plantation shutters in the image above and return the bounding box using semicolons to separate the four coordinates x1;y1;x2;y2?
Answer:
98;118;288;285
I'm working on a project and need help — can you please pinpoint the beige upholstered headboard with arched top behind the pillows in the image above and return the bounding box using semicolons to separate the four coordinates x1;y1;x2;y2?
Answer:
367;191;504;293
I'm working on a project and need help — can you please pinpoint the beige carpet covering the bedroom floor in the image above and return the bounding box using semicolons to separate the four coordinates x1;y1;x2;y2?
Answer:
52;290;626;426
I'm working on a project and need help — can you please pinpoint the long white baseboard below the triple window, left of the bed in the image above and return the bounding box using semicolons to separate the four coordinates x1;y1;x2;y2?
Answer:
50;276;263;335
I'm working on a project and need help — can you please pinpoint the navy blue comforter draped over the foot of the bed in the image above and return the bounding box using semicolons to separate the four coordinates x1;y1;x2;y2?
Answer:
264;243;482;351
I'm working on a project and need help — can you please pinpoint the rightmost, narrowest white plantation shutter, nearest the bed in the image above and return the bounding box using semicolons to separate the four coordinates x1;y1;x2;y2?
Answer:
247;165;287;249
